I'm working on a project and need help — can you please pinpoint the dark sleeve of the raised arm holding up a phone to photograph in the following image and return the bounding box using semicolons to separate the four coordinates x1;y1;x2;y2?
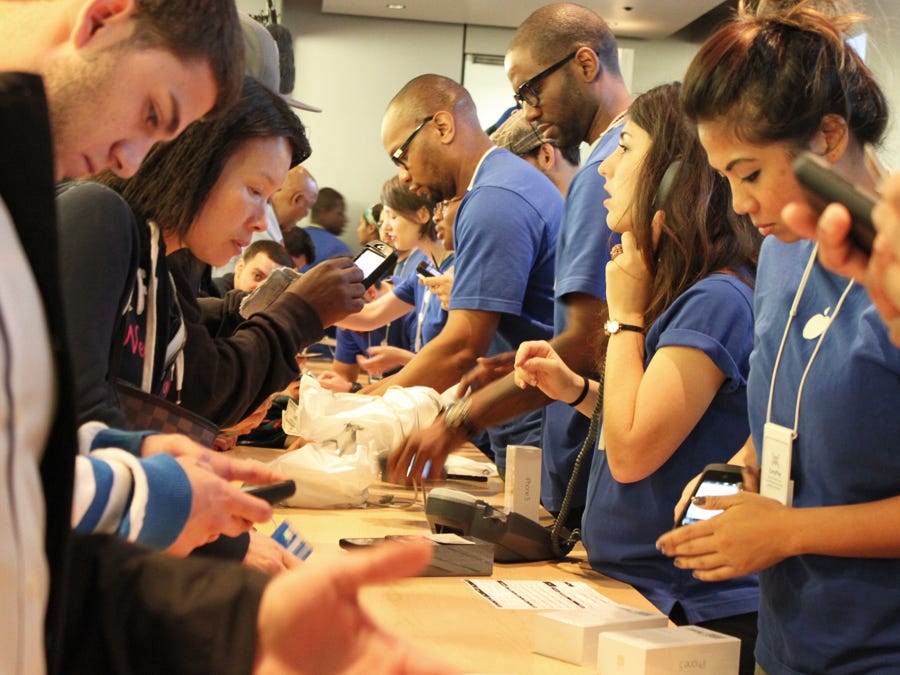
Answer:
173;262;324;427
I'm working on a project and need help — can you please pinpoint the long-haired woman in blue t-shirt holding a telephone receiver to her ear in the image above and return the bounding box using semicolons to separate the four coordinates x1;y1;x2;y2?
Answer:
516;84;760;674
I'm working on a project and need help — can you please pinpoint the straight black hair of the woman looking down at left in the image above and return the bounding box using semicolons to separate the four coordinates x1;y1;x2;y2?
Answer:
98;77;311;238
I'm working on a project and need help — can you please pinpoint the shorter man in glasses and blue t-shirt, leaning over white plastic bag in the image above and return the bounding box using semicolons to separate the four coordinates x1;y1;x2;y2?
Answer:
374;75;563;477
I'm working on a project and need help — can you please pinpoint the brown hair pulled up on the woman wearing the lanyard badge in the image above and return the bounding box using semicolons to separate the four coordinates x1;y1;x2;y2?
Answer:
683;0;888;149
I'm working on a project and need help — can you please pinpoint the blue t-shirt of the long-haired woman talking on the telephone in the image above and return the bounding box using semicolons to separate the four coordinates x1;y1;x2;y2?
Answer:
581;274;758;623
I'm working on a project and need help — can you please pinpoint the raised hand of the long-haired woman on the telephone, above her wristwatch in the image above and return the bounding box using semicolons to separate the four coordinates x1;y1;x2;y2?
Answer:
606;230;652;326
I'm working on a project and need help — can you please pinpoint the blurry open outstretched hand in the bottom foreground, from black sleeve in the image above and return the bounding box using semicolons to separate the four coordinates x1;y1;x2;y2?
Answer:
254;540;458;675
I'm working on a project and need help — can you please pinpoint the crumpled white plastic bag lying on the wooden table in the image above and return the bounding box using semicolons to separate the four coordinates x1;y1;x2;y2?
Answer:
271;375;444;508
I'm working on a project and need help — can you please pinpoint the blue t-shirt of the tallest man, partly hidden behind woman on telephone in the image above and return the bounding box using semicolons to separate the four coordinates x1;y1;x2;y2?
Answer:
541;120;625;513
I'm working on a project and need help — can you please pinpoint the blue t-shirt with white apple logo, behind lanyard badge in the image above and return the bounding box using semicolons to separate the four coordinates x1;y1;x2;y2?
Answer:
748;237;900;675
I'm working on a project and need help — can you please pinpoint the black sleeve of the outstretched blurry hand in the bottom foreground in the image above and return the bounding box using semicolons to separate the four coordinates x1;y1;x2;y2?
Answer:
62;535;269;675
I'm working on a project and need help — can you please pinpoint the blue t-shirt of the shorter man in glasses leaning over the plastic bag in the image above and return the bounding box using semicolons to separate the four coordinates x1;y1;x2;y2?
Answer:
450;149;563;471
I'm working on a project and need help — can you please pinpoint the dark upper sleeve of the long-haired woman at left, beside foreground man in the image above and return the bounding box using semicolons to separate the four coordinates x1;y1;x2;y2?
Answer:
56;183;138;426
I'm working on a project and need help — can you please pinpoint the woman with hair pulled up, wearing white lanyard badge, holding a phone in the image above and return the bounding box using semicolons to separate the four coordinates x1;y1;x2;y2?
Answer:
658;1;900;675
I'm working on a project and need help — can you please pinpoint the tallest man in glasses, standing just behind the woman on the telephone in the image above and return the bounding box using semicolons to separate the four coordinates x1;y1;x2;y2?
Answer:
388;3;631;527
